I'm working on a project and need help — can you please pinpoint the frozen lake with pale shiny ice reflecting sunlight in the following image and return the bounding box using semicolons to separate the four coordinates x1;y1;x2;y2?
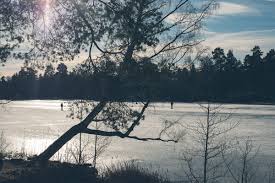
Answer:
0;100;275;181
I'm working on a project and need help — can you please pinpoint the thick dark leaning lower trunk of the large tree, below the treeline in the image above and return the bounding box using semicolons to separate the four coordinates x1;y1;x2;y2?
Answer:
36;101;106;162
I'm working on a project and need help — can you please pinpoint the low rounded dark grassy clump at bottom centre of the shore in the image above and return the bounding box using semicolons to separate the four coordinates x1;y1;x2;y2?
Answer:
103;162;170;183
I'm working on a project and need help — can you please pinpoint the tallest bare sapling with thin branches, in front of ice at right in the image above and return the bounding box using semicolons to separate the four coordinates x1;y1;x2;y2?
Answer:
181;103;238;183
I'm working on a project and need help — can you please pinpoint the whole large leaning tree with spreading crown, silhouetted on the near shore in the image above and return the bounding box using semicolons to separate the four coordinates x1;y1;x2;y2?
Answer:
28;0;217;161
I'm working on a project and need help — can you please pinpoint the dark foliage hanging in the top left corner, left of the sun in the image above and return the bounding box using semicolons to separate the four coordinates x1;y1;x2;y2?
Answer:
0;0;40;64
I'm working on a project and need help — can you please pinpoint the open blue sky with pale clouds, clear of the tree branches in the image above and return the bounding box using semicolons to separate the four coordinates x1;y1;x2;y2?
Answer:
0;0;275;75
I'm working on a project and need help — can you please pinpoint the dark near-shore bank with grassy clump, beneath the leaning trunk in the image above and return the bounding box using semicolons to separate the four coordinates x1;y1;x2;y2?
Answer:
0;160;174;183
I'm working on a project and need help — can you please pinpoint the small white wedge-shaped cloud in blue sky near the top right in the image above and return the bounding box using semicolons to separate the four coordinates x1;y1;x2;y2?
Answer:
214;2;259;16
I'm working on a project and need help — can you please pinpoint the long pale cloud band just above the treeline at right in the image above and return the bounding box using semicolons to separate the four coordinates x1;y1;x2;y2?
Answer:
203;29;275;59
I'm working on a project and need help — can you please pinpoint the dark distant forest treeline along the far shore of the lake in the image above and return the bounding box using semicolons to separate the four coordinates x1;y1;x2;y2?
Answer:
0;46;275;103
